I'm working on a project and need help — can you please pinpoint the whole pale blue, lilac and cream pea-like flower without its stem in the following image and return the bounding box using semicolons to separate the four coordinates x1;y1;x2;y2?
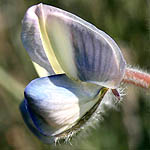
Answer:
20;4;126;143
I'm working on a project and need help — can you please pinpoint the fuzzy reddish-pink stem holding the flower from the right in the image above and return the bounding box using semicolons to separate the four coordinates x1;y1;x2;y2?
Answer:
123;68;150;89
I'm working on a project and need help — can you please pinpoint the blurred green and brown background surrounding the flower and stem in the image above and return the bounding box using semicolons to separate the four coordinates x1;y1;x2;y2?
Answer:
0;0;150;150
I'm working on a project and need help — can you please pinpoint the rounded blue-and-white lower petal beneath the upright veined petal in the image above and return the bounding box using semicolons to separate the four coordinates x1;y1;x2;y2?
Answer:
25;75;103;136
